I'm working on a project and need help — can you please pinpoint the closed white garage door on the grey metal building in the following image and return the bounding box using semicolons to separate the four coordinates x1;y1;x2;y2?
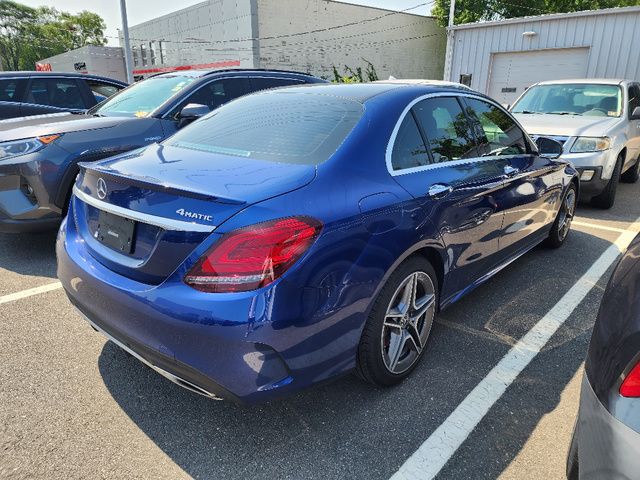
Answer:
488;48;589;104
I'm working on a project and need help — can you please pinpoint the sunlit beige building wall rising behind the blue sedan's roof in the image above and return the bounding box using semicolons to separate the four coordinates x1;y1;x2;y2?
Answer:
257;0;446;79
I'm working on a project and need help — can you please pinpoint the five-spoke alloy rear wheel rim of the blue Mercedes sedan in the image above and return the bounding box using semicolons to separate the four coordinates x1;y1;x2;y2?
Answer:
381;272;436;374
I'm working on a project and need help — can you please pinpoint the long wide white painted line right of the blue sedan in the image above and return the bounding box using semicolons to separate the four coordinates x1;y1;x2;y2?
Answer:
391;218;640;480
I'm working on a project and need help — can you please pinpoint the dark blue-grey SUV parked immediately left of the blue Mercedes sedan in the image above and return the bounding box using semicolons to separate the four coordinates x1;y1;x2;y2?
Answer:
0;70;324;232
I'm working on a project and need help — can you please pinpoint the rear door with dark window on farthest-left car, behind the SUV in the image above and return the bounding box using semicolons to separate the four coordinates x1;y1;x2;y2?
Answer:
21;77;87;116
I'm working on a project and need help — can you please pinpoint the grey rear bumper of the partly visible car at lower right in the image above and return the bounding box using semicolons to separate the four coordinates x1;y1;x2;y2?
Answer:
574;375;640;480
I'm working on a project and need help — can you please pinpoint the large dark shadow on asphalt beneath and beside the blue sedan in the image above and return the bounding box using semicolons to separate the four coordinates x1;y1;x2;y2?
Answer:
92;232;609;479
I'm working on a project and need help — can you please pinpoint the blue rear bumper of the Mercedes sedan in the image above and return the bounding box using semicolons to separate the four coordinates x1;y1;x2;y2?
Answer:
56;204;359;403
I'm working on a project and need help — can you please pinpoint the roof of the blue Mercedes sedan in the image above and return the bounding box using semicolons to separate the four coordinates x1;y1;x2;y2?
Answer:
260;82;476;103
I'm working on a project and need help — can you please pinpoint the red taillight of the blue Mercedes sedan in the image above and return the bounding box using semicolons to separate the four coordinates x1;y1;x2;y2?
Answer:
184;217;322;293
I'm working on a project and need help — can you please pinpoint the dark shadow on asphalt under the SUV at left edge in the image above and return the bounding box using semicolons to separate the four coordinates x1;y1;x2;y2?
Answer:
0;232;56;278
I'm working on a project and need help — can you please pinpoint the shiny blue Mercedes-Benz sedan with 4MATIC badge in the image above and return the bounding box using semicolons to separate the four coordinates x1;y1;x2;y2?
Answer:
57;83;579;403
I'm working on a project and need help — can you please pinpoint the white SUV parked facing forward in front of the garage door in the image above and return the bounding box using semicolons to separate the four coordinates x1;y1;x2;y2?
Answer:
511;79;640;208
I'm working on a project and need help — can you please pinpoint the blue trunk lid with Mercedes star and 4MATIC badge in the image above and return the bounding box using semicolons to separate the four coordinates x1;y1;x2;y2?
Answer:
74;145;315;284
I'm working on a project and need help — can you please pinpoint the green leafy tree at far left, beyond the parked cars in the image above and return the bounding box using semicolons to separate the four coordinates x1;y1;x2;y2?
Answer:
0;0;107;70
